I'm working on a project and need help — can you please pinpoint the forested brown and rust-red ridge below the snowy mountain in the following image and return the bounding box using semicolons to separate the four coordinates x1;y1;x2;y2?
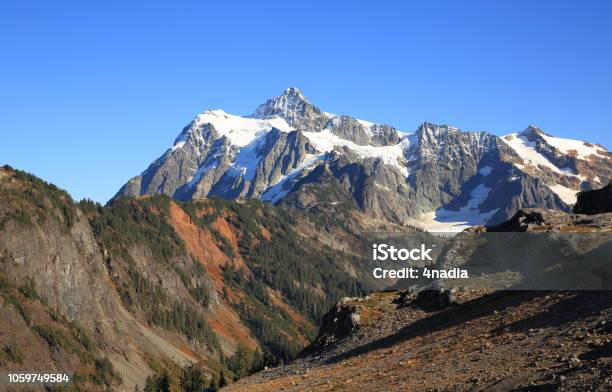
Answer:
0;166;392;391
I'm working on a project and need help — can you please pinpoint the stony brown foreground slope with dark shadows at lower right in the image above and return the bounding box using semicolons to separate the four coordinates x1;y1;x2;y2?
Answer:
224;186;612;391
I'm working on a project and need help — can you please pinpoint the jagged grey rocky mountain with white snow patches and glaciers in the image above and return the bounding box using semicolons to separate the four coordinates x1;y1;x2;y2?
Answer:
115;88;612;231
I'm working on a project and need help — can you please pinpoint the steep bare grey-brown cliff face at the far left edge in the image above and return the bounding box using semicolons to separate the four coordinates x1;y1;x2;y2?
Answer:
0;169;130;390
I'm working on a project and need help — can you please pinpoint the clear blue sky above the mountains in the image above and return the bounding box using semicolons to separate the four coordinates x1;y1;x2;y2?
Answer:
0;1;612;202
